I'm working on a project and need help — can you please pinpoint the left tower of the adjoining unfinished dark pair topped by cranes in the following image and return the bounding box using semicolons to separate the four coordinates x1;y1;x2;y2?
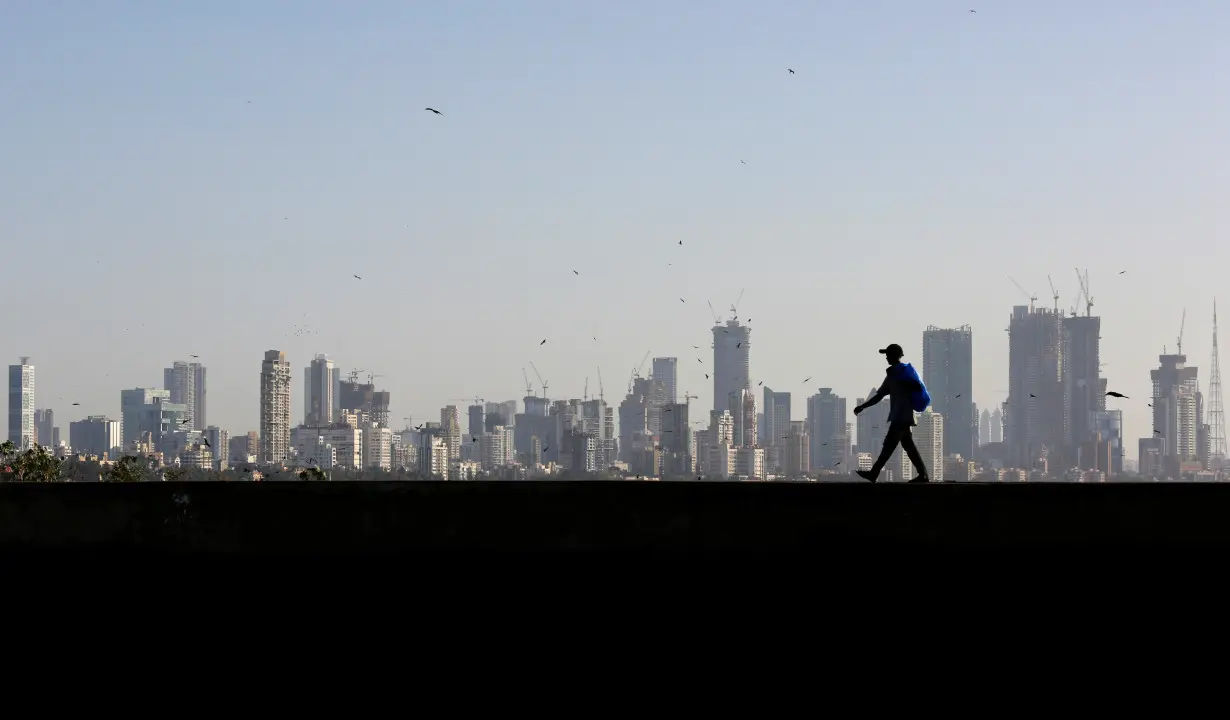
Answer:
1004;305;1068;470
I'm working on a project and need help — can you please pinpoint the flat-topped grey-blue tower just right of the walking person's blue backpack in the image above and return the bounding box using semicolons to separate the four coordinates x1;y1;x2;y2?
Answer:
923;325;977;458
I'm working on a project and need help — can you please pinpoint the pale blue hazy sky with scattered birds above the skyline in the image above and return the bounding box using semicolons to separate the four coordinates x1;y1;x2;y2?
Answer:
0;0;1230;457
